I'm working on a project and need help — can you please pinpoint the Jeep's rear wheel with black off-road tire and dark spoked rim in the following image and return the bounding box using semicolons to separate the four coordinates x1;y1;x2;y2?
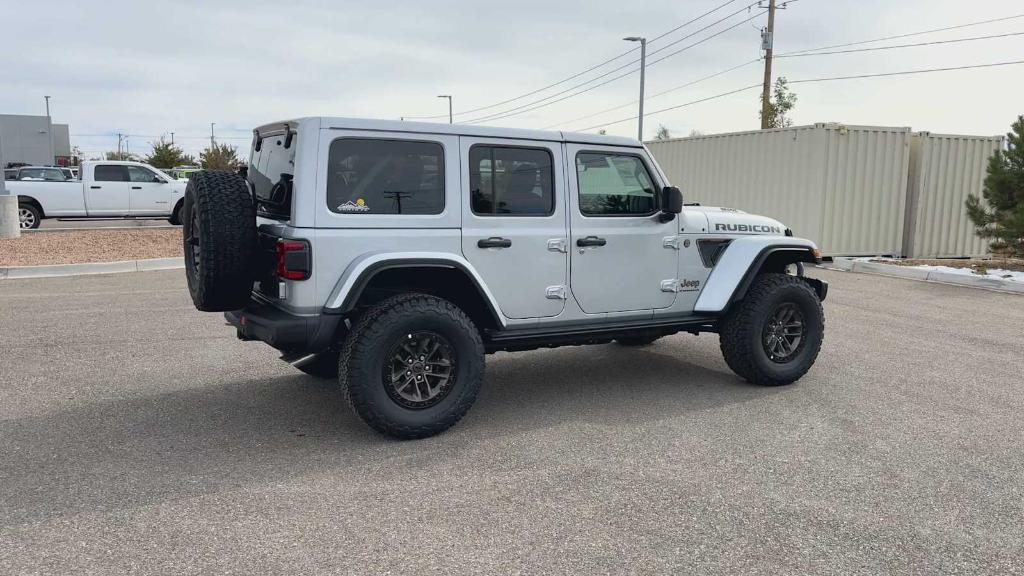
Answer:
339;294;484;439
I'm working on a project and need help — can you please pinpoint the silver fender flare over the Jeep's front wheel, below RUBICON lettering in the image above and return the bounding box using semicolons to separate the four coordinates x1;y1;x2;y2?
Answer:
693;236;824;314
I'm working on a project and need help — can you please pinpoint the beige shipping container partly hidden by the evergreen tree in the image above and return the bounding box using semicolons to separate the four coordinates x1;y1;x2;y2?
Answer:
904;132;1002;258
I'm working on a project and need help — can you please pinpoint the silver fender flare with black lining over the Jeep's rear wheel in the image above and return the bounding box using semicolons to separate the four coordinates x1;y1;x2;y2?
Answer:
324;252;507;328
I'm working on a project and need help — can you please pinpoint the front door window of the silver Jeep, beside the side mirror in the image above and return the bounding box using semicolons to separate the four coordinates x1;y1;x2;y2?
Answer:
577;152;657;216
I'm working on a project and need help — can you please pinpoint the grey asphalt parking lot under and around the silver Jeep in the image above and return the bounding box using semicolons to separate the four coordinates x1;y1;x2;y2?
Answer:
0;271;1024;574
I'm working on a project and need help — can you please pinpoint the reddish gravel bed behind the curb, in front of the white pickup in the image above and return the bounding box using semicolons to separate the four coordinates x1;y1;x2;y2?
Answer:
0;228;181;266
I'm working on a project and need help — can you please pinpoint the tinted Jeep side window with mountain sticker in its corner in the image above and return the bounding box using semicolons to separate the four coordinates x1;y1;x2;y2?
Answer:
327;138;444;214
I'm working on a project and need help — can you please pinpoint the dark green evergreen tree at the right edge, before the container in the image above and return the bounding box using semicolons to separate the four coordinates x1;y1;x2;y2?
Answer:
966;116;1024;257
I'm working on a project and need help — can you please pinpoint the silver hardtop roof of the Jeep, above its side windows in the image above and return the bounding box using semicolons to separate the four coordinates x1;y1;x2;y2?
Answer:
257;117;643;148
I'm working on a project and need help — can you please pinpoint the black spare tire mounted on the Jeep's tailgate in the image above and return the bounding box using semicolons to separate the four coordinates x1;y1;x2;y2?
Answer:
181;170;257;312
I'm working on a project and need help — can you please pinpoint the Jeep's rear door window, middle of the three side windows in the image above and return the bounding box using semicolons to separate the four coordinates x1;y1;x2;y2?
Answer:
469;146;555;216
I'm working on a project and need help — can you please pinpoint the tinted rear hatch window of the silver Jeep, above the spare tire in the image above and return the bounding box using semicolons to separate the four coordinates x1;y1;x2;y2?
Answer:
246;128;299;220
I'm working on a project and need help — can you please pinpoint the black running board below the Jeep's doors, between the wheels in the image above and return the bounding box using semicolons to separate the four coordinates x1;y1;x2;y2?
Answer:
483;316;719;353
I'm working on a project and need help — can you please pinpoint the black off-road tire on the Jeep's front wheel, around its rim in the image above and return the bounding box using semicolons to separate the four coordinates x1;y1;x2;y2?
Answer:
719;274;824;386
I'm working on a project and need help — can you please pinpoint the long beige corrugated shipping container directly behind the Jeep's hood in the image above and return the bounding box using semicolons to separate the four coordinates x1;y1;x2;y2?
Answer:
646;124;911;256
